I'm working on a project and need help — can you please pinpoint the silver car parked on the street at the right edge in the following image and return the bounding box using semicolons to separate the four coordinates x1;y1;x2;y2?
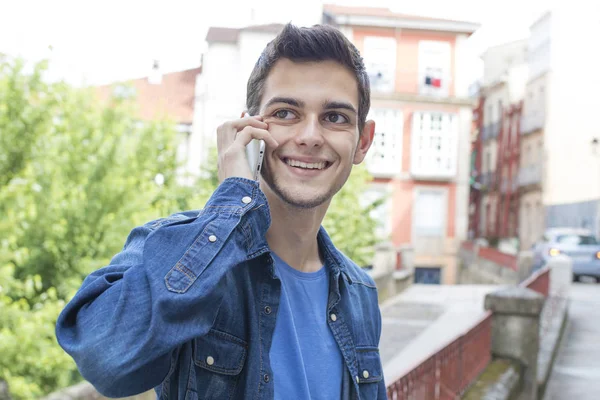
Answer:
533;228;600;282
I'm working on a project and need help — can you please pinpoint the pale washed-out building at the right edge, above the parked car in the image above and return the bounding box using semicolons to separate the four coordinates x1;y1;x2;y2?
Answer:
519;3;600;248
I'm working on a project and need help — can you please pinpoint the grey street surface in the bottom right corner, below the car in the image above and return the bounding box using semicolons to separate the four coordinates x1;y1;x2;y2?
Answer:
544;282;600;400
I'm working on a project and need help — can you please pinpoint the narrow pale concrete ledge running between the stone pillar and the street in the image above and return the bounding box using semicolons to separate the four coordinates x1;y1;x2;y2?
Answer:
537;297;569;399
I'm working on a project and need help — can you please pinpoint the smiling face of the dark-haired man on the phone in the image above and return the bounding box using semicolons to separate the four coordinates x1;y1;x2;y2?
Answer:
260;59;374;208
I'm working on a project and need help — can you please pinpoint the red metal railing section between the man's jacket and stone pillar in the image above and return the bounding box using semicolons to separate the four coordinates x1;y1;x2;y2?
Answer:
387;312;492;400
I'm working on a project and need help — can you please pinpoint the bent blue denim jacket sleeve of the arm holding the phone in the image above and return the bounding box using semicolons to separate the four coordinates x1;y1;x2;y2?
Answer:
56;178;270;397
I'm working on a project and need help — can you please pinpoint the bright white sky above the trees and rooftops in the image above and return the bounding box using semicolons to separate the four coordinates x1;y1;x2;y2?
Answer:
0;0;552;84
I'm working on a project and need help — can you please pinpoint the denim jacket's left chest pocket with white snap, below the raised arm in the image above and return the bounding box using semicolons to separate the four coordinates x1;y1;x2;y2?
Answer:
190;329;248;400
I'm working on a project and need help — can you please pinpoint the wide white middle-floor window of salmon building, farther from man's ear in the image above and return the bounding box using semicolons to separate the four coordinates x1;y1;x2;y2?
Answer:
411;112;458;179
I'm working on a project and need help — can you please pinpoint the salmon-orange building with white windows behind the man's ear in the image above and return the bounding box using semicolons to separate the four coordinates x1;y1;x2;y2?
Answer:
324;6;478;283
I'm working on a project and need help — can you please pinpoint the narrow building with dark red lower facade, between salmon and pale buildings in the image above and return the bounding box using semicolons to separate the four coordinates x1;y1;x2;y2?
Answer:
470;40;527;252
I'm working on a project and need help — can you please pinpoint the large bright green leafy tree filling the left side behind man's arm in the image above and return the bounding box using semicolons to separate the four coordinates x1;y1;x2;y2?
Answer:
0;60;216;399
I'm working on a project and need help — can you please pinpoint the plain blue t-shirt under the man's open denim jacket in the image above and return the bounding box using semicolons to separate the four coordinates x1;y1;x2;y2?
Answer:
269;253;343;400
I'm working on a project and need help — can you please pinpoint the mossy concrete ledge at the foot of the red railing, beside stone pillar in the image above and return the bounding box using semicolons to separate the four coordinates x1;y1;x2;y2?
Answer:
461;359;522;400
